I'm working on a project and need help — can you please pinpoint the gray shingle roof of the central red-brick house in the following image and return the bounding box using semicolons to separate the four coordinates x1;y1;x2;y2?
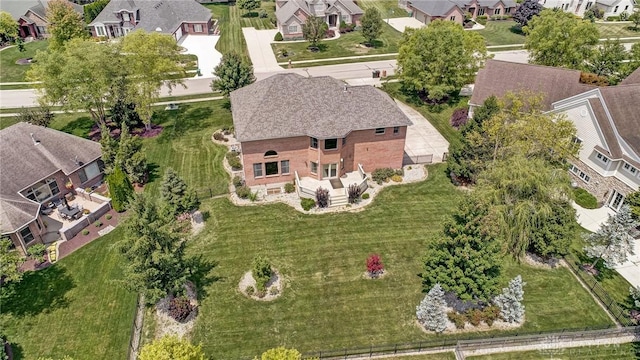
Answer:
231;74;411;142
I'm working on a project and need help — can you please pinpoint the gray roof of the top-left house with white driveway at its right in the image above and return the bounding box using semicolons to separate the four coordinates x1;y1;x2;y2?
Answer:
89;0;211;34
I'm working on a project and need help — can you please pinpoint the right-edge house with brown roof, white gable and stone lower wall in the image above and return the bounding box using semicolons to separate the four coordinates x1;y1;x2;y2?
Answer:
469;60;640;210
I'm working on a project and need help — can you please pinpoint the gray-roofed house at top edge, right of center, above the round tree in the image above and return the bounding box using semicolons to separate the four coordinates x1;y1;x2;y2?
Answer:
398;0;517;24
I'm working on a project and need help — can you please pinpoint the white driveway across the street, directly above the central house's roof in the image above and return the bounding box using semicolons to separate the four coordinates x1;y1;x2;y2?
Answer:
242;27;282;73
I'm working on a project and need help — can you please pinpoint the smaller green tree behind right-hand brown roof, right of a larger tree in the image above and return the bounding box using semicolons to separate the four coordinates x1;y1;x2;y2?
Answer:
586;40;627;85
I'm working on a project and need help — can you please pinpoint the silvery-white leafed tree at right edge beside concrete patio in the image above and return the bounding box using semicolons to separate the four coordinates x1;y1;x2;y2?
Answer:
584;205;640;268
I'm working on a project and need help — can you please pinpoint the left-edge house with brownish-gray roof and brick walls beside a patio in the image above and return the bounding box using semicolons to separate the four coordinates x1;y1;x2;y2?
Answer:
0;122;102;254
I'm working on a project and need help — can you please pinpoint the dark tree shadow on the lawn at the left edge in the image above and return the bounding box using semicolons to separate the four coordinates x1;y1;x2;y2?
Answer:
0;265;76;317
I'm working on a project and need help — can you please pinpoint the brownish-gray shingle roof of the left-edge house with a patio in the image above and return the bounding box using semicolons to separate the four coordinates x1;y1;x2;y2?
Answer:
0;123;102;233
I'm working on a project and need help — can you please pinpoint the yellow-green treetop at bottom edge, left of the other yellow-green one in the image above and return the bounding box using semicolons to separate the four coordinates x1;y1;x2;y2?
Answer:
138;336;206;360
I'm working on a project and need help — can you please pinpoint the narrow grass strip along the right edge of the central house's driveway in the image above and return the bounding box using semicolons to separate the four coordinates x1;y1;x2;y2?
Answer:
383;82;469;148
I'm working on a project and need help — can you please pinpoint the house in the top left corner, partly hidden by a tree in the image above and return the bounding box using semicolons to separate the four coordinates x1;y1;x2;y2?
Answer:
0;0;84;38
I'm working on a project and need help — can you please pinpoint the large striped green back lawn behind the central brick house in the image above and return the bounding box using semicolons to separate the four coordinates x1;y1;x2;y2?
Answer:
188;165;611;358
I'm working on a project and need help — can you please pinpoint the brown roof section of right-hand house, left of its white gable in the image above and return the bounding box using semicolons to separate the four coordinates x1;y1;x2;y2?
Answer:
469;60;595;110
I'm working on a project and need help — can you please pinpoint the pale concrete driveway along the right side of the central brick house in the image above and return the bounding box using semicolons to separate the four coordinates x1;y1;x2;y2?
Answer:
396;100;449;163
